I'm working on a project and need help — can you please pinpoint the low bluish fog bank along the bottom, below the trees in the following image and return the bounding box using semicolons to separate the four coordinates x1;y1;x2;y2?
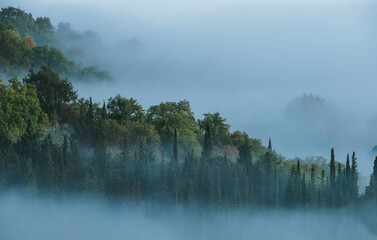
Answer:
0;193;375;240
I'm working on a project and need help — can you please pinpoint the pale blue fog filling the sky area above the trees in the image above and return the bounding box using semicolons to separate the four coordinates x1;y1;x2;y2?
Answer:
0;0;377;175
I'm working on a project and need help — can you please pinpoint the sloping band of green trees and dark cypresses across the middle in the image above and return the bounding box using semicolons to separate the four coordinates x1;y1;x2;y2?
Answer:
0;65;377;214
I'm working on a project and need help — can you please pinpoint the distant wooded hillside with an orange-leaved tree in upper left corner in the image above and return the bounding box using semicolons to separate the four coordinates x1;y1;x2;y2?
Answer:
0;7;111;81
